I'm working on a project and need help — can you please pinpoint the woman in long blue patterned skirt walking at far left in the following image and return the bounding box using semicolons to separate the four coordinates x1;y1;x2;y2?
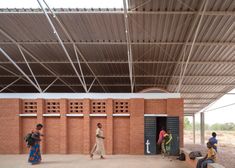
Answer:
28;124;43;164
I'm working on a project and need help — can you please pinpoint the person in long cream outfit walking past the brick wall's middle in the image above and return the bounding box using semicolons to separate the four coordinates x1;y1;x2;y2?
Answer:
90;123;105;159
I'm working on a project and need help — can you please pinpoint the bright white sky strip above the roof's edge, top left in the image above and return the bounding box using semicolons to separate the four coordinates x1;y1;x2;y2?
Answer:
0;0;123;8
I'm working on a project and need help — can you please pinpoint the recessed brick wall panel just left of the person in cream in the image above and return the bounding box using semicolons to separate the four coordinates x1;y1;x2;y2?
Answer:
68;117;85;154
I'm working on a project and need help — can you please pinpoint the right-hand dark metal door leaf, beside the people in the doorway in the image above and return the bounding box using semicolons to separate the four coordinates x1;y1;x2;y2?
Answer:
167;117;180;155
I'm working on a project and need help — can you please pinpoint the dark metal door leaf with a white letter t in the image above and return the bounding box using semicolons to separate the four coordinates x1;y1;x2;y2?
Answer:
144;117;157;155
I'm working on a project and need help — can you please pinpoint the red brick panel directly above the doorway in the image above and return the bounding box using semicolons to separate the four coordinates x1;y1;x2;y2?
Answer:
144;100;167;114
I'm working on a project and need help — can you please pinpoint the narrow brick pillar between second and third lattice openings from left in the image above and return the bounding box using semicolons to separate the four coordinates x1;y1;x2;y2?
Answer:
60;99;68;154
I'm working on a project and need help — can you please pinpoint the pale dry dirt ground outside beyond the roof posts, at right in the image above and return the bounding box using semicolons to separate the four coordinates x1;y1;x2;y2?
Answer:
184;131;235;168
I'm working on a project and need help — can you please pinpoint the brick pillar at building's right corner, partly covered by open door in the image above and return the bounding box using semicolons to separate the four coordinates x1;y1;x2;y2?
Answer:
167;99;184;147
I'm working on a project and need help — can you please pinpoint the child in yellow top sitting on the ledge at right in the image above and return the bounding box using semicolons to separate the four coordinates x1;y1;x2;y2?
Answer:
196;142;216;168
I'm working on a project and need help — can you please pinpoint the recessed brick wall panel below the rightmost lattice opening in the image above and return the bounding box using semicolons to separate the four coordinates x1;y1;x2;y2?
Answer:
113;117;130;154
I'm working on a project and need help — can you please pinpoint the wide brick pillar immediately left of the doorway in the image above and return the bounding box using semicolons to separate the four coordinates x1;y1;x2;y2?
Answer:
129;99;144;154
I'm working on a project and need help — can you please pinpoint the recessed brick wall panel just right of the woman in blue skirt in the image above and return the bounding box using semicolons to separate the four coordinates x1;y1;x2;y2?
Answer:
44;117;60;153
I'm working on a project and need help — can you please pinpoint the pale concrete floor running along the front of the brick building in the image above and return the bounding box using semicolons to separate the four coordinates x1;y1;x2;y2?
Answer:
0;155;189;168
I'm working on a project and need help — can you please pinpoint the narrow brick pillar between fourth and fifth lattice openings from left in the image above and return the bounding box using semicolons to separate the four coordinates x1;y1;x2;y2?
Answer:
105;99;113;154
